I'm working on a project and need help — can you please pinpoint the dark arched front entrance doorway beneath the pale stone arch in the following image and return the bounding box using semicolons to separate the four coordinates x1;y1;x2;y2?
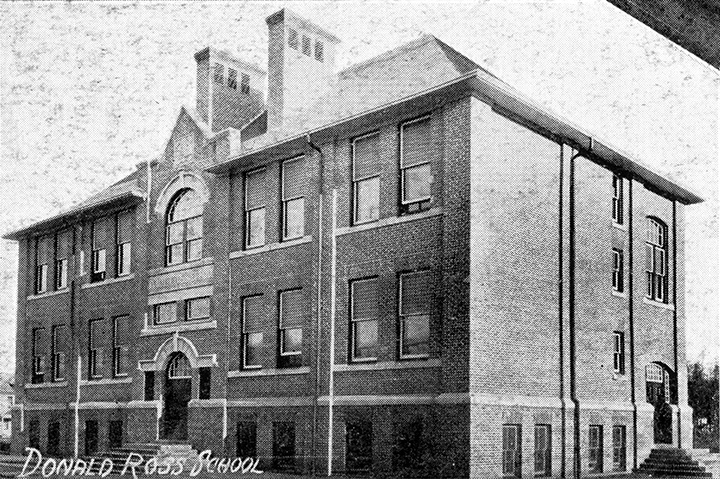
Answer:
161;352;192;439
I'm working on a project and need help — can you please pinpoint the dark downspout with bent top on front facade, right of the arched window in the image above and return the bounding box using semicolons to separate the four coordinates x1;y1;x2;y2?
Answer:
306;133;325;476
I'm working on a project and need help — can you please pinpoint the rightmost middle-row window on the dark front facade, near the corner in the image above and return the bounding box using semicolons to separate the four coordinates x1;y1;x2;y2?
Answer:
398;271;432;358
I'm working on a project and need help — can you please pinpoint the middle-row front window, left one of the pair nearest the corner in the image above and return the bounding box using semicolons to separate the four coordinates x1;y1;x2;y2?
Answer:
350;278;378;361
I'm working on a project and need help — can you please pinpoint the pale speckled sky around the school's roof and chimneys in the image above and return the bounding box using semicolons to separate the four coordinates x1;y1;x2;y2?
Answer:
0;0;720;371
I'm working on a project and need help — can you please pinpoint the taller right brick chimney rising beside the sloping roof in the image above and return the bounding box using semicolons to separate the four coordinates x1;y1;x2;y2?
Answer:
266;8;340;132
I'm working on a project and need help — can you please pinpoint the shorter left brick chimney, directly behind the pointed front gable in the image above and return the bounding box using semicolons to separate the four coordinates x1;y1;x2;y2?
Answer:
195;47;265;131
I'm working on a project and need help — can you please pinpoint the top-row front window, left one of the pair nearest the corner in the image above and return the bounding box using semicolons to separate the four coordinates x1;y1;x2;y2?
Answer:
352;133;380;224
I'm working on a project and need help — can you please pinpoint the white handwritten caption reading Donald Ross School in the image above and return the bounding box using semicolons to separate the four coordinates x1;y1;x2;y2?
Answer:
18;447;263;479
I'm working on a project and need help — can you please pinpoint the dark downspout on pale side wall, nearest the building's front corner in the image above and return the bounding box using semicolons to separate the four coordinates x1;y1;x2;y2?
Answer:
568;148;593;479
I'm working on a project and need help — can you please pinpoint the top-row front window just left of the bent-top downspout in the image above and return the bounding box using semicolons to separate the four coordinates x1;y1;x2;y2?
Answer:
282;157;306;240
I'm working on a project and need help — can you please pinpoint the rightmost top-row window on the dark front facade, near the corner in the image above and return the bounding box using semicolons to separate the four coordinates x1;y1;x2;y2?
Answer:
400;116;433;214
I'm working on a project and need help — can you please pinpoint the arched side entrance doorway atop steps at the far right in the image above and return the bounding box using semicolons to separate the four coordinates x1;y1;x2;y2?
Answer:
645;363;675;444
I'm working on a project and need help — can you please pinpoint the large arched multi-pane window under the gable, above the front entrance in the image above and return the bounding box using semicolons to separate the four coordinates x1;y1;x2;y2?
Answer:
165;188;203;265
